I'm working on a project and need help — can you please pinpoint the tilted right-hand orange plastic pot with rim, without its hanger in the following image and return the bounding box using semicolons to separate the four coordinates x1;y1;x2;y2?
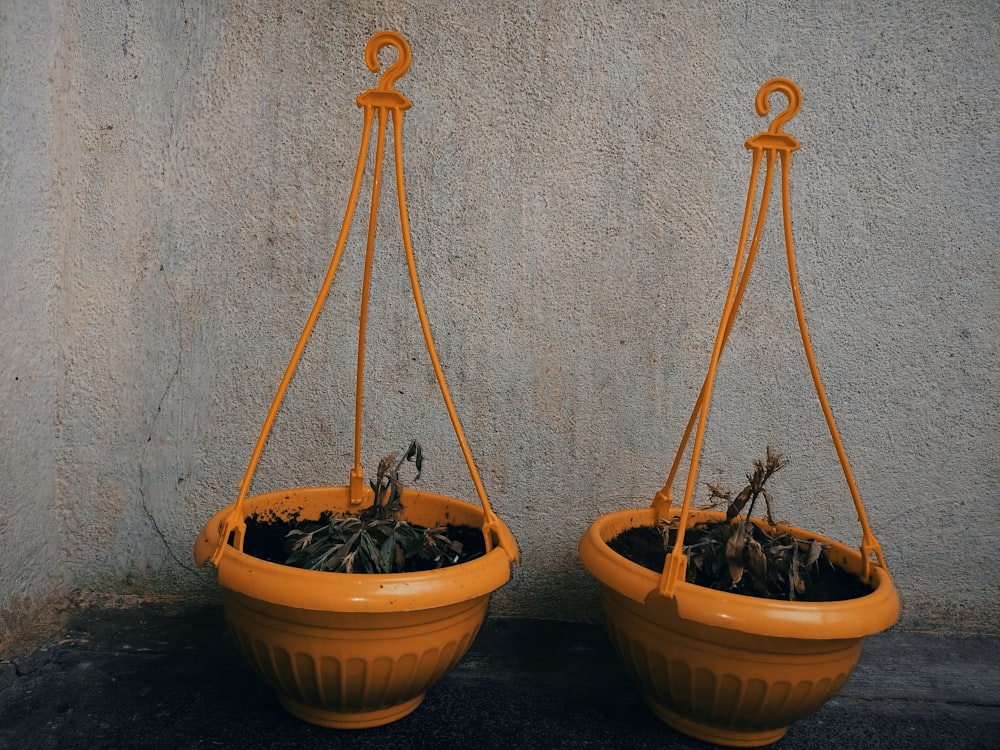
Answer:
579;508;899;747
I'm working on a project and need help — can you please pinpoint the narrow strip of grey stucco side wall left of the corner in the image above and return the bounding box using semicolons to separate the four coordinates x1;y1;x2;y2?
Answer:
0;0;68;635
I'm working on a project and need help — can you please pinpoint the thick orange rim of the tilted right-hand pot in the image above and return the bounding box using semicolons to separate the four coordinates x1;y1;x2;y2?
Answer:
579;507;899;639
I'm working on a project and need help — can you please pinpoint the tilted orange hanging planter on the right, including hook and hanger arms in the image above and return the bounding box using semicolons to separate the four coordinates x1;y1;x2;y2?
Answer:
579;78;899;747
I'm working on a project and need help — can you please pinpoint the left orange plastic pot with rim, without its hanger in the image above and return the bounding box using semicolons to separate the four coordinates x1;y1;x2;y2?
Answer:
195;487;516;729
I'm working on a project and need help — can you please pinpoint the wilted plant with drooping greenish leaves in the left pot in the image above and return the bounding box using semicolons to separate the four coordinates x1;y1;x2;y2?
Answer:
285;440;463;573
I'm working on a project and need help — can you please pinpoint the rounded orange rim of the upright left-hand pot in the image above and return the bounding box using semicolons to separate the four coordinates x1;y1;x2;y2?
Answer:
195;487;513;613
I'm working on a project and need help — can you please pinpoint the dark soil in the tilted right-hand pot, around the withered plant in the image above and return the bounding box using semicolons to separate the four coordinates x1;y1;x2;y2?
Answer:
608;523;873;602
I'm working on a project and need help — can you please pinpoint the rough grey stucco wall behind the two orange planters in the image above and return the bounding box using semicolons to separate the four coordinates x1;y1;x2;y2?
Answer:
0;0;1000;633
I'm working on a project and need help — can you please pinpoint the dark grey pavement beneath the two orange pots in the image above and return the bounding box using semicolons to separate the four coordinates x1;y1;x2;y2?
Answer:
0;603;1000;750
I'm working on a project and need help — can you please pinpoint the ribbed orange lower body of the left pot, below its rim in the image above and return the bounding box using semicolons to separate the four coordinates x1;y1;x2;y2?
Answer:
223;592;489;729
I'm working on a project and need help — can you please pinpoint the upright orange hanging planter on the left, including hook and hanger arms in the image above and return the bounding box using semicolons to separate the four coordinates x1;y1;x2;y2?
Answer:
194;31;518;728
